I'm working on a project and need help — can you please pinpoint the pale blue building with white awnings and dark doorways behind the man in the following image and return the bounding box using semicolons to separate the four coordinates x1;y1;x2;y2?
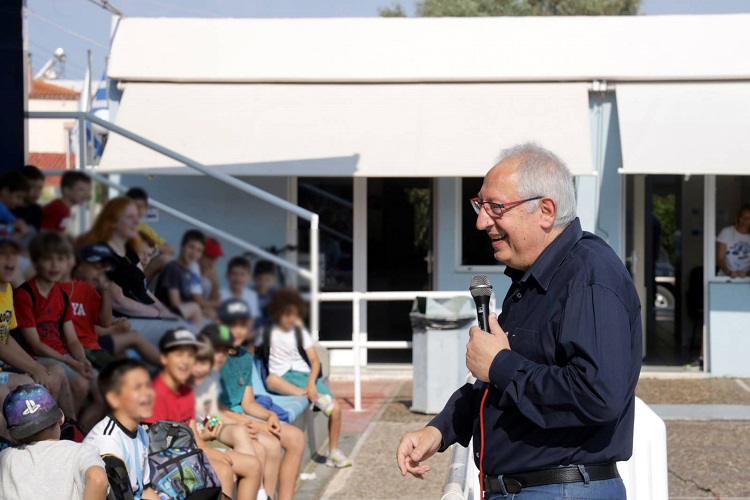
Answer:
100;15;750;376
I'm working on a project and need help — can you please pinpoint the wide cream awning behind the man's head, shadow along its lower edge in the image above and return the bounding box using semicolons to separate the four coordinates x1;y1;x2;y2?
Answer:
100;83;593;177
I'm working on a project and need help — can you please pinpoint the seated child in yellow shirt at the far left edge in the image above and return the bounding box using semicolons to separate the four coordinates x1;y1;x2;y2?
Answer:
0;238;76;420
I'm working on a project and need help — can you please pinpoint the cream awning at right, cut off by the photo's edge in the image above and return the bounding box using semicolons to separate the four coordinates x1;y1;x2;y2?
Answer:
616;82;750;175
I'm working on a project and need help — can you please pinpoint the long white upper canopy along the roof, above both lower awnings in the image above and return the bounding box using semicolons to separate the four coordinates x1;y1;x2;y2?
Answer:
108;15;750;83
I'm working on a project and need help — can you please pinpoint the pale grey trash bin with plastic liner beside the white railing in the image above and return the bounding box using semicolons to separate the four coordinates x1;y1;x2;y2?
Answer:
409;297;476;414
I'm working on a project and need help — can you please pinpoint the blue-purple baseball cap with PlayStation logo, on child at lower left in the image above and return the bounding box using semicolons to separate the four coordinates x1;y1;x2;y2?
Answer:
3;384;63;440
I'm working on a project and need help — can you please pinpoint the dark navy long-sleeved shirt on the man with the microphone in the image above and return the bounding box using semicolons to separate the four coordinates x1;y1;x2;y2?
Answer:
429;219;641;475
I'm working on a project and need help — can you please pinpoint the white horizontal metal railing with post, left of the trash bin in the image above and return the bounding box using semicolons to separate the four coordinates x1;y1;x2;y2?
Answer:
320;290;471;411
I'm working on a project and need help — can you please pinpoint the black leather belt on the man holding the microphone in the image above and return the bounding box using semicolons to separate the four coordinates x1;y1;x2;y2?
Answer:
481;463;620;494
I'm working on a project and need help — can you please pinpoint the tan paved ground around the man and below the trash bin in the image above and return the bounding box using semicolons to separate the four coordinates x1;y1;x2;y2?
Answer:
296;376;750;500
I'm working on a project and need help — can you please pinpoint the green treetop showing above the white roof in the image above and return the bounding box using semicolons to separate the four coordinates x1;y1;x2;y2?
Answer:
379;0;642;17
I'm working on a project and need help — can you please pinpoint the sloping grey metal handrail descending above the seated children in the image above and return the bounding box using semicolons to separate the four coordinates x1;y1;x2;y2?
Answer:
26;111;320;340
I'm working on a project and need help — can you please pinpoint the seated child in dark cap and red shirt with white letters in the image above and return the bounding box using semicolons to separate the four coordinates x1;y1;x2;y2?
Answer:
60;245;160;369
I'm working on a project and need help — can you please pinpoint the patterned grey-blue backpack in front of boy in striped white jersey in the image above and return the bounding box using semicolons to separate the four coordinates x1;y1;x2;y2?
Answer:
147;420;221;500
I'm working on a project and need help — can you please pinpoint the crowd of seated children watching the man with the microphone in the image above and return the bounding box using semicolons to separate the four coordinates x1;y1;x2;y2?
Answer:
0;167;351;499
